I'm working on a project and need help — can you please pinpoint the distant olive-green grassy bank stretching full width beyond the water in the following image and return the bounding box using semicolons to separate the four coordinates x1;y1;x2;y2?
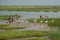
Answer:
0;6;60;12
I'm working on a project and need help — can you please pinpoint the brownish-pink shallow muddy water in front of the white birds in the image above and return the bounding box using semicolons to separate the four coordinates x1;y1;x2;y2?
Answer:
13;23;50;31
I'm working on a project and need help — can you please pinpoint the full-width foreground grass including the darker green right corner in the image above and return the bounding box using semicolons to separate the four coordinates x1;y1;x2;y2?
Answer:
0;30;60;40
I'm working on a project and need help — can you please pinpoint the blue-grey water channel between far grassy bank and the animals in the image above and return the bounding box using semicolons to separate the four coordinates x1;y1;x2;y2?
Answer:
0;11;60;20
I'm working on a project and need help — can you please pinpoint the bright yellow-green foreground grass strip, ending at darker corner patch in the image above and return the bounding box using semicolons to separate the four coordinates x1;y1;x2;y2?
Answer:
0;30;48;40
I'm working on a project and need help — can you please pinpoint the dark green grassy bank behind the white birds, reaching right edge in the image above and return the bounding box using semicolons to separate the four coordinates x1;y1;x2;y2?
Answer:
27;18;60;27
